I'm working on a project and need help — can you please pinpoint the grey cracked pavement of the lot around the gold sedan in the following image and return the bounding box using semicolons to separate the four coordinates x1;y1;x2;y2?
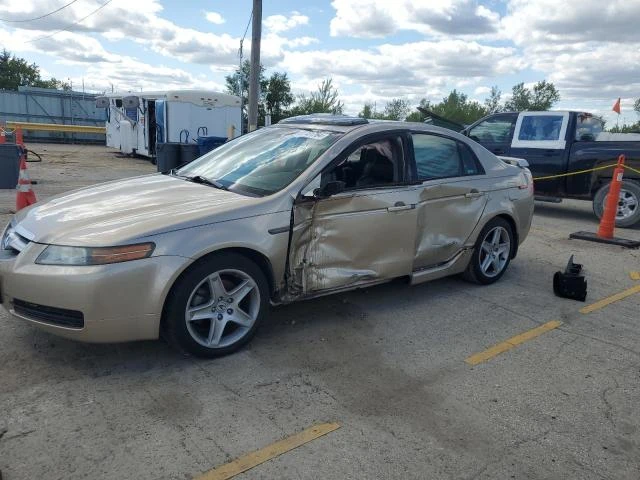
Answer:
0;145;640;480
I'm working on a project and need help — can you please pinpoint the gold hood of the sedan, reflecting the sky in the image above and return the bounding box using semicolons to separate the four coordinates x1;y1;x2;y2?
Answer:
15;174;264;246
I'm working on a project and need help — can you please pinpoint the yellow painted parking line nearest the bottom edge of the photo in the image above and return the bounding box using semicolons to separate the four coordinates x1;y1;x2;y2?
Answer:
195;423;340;480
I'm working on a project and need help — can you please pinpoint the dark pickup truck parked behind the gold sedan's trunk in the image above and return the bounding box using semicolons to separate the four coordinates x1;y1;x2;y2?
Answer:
440;111;640;227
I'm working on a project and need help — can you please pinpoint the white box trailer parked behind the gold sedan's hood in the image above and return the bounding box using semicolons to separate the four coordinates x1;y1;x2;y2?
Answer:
96;90;242;157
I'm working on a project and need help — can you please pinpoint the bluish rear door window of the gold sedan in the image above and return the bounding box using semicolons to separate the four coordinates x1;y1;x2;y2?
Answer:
413;133;464;180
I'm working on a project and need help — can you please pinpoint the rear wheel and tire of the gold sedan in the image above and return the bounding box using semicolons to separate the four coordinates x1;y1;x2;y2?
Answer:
463;218;514;285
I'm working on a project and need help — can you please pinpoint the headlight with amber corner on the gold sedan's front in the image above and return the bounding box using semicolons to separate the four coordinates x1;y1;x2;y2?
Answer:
36;242;155;266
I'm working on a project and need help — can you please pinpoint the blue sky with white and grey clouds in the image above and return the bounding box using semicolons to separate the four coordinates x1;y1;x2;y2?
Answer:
0;0;640;123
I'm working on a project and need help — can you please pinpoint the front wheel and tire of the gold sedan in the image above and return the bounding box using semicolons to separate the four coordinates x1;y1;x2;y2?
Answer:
163;253;269;358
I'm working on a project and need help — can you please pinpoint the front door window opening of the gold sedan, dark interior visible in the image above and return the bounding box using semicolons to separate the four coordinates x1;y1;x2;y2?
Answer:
321;137;404;190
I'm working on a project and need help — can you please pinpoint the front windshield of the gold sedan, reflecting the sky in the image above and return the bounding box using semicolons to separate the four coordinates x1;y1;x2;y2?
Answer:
177;127;342;196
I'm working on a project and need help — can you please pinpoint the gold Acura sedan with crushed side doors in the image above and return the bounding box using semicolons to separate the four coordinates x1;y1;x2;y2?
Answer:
0;115;533;356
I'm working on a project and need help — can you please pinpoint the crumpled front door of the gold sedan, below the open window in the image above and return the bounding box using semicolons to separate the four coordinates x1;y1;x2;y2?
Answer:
290;186;417;294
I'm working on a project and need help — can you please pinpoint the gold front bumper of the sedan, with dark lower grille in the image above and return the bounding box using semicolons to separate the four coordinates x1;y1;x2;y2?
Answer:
0;243;191;343
